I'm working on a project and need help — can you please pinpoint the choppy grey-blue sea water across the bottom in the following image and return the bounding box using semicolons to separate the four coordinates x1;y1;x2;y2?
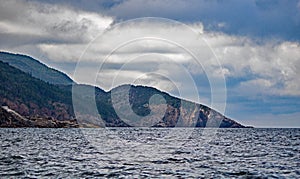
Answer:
0;128;300;178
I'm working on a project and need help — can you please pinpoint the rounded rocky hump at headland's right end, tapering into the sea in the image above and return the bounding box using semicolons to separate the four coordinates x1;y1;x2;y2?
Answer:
105;85;245;128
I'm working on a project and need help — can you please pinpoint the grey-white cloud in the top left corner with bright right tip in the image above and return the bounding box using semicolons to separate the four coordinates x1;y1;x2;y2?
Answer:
0;0;113;47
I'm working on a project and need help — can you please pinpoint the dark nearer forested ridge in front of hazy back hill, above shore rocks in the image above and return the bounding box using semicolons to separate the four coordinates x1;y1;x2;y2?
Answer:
0;51;250;128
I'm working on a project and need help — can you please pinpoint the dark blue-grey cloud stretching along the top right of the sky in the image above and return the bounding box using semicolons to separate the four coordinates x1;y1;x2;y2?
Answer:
108;0;300;41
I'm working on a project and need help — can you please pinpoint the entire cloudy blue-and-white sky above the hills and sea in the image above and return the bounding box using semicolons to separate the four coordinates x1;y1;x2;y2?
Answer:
0;0;300;127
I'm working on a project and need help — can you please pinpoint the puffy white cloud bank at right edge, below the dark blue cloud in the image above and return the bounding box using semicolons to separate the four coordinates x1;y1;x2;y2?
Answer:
214;39;300;95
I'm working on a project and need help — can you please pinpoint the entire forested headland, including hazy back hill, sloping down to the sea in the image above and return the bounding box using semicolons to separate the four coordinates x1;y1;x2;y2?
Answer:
0;52;251;128
